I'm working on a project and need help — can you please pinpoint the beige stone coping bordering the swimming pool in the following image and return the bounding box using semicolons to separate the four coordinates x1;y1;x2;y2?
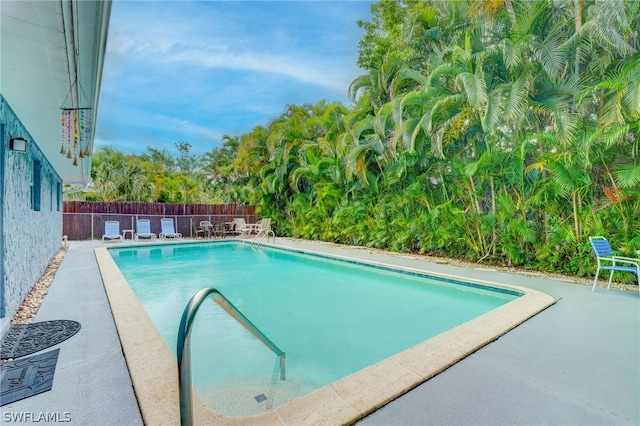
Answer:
95;244;555;425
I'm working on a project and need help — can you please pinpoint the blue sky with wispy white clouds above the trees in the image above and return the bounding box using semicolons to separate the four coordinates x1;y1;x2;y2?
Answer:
95;0;372;155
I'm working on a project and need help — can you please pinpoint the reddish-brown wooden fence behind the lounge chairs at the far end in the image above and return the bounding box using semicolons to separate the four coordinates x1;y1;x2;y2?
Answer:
62;201;260;241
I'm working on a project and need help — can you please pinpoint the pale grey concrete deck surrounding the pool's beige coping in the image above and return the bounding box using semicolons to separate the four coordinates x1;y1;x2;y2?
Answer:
2;240;640;425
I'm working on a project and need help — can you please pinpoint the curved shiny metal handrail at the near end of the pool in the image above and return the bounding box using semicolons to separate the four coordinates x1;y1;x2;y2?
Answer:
177;287;286;426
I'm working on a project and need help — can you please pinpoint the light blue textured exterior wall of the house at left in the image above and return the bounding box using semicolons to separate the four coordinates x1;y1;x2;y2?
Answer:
0;95;62;335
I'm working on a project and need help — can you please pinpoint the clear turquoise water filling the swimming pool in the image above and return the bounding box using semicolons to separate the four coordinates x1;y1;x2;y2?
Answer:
109;242;518;415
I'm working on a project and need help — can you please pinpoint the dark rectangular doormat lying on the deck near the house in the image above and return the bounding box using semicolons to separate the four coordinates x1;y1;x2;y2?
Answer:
0;349;60;406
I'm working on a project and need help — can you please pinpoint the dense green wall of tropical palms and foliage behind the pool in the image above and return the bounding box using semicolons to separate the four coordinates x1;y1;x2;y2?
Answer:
77;0;640;279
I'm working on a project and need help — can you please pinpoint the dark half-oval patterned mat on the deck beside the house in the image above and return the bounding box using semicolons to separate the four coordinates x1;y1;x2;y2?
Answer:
0;320;80;359
